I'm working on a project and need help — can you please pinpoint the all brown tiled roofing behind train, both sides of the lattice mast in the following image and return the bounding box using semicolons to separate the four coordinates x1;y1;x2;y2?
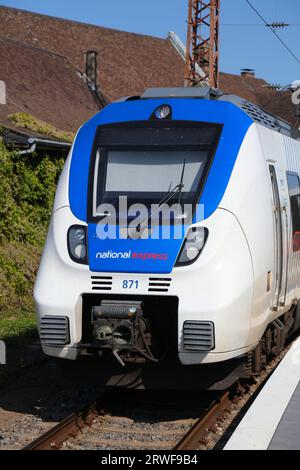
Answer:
0;6;296;130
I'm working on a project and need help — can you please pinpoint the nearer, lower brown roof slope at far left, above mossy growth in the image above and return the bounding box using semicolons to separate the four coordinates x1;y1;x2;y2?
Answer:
0;35;98;131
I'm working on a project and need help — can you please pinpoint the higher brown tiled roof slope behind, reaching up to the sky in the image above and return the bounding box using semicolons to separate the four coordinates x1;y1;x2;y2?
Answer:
0;7;184;100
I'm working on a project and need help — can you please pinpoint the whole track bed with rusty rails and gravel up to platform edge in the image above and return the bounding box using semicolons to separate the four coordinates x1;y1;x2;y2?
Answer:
23;334;289;450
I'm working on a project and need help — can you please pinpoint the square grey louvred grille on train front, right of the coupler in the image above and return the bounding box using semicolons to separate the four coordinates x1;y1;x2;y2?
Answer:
183;320;215;351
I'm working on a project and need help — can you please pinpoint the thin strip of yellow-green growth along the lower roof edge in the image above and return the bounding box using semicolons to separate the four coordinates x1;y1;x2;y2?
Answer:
8;113;74;142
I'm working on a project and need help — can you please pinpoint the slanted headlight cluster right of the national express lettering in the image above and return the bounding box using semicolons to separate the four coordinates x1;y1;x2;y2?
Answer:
175;227;208;266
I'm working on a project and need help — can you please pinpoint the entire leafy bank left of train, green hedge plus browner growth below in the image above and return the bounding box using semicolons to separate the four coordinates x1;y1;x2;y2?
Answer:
0;142;64;338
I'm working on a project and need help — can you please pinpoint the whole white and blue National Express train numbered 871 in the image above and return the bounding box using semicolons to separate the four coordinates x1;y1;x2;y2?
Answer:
34;88;300;390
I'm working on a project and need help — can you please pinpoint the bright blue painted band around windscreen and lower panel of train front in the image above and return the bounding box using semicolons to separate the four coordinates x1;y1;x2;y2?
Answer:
69;98;253;273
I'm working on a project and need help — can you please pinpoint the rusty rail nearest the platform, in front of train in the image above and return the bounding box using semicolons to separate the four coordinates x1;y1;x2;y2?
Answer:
173;390;232;450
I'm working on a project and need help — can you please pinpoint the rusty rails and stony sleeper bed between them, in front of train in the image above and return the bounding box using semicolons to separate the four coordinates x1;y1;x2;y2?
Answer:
23;391;231;450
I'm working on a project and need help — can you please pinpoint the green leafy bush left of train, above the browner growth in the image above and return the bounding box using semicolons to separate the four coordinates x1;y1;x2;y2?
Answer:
0;144;64;246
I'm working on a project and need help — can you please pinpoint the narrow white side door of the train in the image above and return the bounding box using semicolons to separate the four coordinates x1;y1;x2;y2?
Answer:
269;162;288;310
